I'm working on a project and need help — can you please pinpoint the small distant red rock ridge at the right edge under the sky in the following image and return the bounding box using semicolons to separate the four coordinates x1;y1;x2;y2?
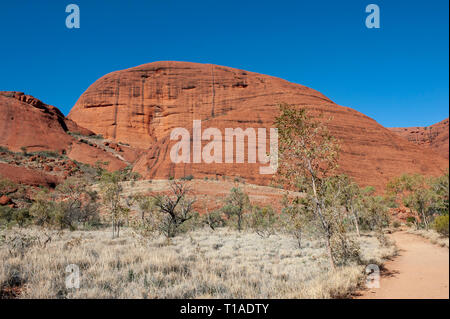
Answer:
389;118;449;159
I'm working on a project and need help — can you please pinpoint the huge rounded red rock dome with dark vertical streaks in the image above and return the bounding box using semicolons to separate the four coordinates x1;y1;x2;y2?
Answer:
69;62;448;192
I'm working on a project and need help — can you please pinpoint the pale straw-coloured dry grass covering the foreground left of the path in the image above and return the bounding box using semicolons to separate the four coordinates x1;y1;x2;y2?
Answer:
0;228;393;298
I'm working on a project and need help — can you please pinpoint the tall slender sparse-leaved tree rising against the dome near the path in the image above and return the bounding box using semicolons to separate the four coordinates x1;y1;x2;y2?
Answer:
275;104;352;269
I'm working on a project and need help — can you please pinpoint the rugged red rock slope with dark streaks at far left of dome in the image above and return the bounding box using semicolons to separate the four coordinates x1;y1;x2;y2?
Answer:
0;92;136;186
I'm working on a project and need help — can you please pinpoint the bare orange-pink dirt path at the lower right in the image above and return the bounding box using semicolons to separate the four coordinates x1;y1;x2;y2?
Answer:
358;231;449;299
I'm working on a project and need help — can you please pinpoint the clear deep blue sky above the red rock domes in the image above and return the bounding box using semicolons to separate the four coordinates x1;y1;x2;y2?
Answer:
0;0;449;126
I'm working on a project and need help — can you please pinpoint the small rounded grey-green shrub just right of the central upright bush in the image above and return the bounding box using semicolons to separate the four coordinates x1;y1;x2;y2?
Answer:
247;206;279;237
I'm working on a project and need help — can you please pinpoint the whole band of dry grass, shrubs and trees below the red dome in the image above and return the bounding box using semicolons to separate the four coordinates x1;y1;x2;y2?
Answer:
0;105;449;298
